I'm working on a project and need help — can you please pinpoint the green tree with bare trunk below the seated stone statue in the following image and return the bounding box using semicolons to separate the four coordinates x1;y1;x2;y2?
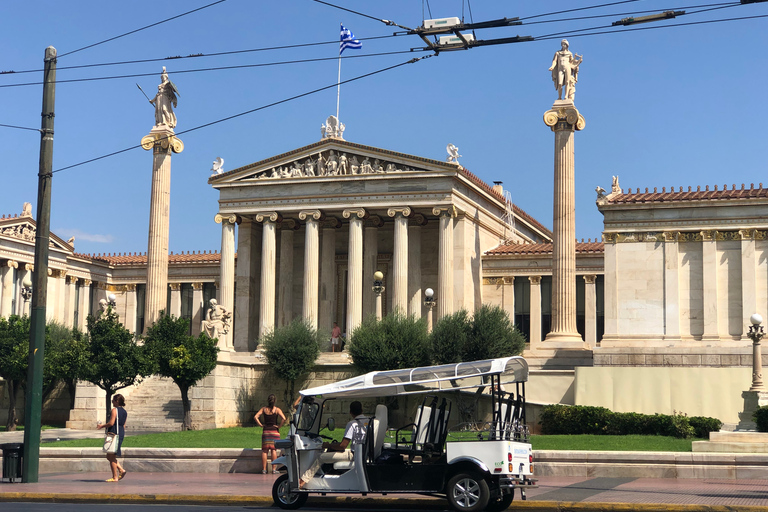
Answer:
144;311;219;430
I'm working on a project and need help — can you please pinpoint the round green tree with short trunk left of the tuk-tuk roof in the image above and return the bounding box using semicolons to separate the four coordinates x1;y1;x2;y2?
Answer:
259;320;320;404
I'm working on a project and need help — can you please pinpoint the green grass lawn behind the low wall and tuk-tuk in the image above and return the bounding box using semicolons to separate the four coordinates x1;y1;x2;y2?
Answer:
43;426;695;452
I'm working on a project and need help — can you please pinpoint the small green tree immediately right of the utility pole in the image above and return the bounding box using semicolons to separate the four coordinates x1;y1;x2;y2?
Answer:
43;322;88;409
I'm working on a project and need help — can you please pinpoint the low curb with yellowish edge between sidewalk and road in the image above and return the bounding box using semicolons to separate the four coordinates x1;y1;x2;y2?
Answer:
0;492;768;512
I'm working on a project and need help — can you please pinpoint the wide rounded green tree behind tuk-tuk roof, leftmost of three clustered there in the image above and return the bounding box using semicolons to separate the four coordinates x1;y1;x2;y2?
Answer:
349;312;432;373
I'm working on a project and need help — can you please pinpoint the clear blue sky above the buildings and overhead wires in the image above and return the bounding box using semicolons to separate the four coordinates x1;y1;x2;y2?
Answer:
0;0;768;253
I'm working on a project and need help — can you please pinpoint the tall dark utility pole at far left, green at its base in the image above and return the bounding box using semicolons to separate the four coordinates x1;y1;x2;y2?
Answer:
21;46;56;483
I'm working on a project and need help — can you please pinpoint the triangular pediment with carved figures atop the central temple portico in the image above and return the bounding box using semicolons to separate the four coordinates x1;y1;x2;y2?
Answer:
209;138;459;186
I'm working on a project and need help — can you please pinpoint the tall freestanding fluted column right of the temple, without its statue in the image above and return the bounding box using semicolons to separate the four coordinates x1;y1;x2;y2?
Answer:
544;100;586;348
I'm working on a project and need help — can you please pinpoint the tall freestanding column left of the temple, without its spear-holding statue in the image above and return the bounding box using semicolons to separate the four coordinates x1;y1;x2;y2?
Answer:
141;125;184;330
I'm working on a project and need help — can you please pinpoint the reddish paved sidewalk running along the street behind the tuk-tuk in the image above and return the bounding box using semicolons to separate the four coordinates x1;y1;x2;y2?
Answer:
0;472;768;512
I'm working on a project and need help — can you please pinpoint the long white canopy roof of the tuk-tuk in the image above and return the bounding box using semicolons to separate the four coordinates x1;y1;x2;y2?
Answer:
300;356;528;398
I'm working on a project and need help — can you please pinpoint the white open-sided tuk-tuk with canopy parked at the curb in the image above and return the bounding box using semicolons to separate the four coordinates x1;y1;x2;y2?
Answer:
272;357;535;512
